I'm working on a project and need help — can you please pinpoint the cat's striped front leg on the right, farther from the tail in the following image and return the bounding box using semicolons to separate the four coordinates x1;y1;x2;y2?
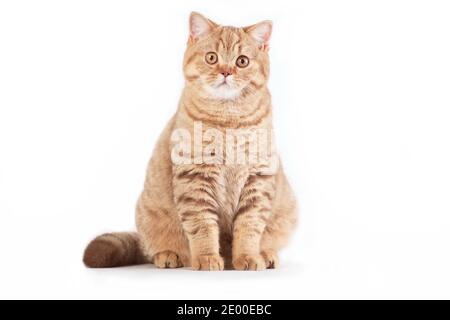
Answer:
233;175;275;270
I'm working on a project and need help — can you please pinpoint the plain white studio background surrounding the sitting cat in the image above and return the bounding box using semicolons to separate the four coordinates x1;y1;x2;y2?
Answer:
0;0;450;299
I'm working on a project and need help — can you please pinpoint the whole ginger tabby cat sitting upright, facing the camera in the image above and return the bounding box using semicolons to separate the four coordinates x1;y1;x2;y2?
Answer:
83;12;297;271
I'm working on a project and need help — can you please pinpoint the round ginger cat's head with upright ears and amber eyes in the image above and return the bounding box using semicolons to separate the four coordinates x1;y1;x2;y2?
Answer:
183;12;272;100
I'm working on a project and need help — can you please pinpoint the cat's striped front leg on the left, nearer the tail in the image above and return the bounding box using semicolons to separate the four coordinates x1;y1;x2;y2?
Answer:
173;165;224;271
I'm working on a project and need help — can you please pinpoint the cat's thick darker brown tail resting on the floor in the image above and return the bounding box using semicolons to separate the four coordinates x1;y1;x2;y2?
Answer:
83;232;147;268
